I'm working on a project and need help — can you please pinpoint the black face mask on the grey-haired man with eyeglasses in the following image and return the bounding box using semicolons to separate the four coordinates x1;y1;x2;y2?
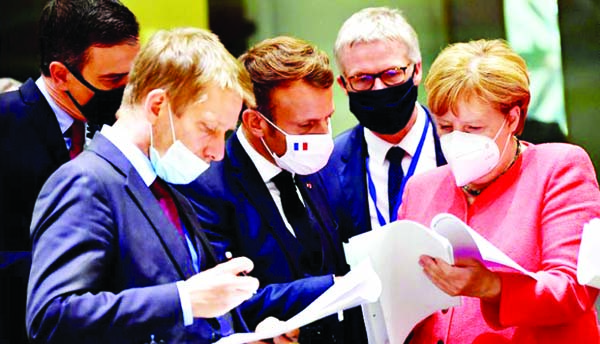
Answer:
348;77;418;134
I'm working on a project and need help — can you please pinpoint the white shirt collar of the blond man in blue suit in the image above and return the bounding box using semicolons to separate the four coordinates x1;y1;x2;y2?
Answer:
100;125;156;187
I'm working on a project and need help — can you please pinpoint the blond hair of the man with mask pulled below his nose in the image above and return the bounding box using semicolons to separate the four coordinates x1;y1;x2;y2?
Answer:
123;28;254;113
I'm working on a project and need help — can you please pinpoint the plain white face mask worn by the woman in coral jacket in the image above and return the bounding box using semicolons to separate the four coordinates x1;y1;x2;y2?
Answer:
440;120;510;187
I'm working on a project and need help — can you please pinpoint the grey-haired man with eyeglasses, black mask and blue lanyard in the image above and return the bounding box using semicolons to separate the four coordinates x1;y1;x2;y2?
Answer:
324;7;446;240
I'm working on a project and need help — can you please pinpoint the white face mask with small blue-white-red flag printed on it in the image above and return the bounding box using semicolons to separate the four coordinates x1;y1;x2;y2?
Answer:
261;114;333;175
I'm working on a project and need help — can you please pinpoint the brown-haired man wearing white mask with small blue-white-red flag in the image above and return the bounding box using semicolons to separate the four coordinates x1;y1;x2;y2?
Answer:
181;36;364;344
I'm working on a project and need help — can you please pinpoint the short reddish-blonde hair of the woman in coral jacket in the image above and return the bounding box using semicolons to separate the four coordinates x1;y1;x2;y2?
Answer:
425;39;531;134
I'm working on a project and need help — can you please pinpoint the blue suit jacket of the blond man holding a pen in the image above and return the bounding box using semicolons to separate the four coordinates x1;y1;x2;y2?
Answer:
27;134;332;343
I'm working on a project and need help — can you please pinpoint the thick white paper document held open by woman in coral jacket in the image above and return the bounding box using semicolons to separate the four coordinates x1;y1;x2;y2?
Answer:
344;214;535;344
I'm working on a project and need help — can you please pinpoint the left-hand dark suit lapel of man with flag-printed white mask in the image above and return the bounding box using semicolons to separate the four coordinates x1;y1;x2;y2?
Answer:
227;135;302;273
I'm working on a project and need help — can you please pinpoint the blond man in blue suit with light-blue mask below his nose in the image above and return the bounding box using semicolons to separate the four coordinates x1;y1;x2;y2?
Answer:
27;28;333;343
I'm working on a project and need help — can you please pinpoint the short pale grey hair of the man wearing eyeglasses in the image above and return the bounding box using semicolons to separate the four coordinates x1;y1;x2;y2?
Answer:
334;7;421;73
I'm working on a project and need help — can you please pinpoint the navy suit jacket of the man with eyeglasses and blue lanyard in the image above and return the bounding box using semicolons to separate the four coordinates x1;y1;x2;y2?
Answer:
322;105;446;242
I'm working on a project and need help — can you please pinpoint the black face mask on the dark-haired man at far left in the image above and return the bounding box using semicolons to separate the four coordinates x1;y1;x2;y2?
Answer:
67;66;125;131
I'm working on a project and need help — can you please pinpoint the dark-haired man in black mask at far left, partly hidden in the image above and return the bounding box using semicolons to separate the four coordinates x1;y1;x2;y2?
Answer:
0;0;139;343
